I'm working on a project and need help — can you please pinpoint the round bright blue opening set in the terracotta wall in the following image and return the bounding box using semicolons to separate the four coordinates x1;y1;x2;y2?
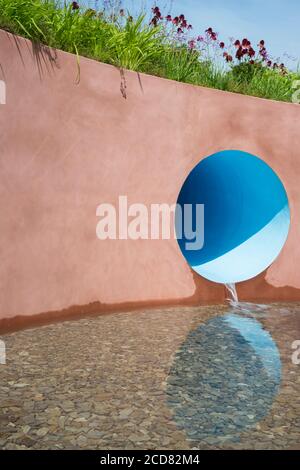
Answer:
176;150;290;283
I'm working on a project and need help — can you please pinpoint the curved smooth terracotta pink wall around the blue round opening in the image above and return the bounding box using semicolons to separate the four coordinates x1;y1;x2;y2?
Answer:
0;31;300;328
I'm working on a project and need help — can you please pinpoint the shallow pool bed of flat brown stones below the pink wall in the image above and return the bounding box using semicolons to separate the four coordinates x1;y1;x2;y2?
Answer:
0;303;300;450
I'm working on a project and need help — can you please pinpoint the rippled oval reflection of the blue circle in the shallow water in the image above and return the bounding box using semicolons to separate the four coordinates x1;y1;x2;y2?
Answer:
167;314;281;440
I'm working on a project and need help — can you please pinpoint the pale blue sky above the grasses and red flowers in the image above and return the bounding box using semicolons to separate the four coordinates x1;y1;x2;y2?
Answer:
119;0;300;69
